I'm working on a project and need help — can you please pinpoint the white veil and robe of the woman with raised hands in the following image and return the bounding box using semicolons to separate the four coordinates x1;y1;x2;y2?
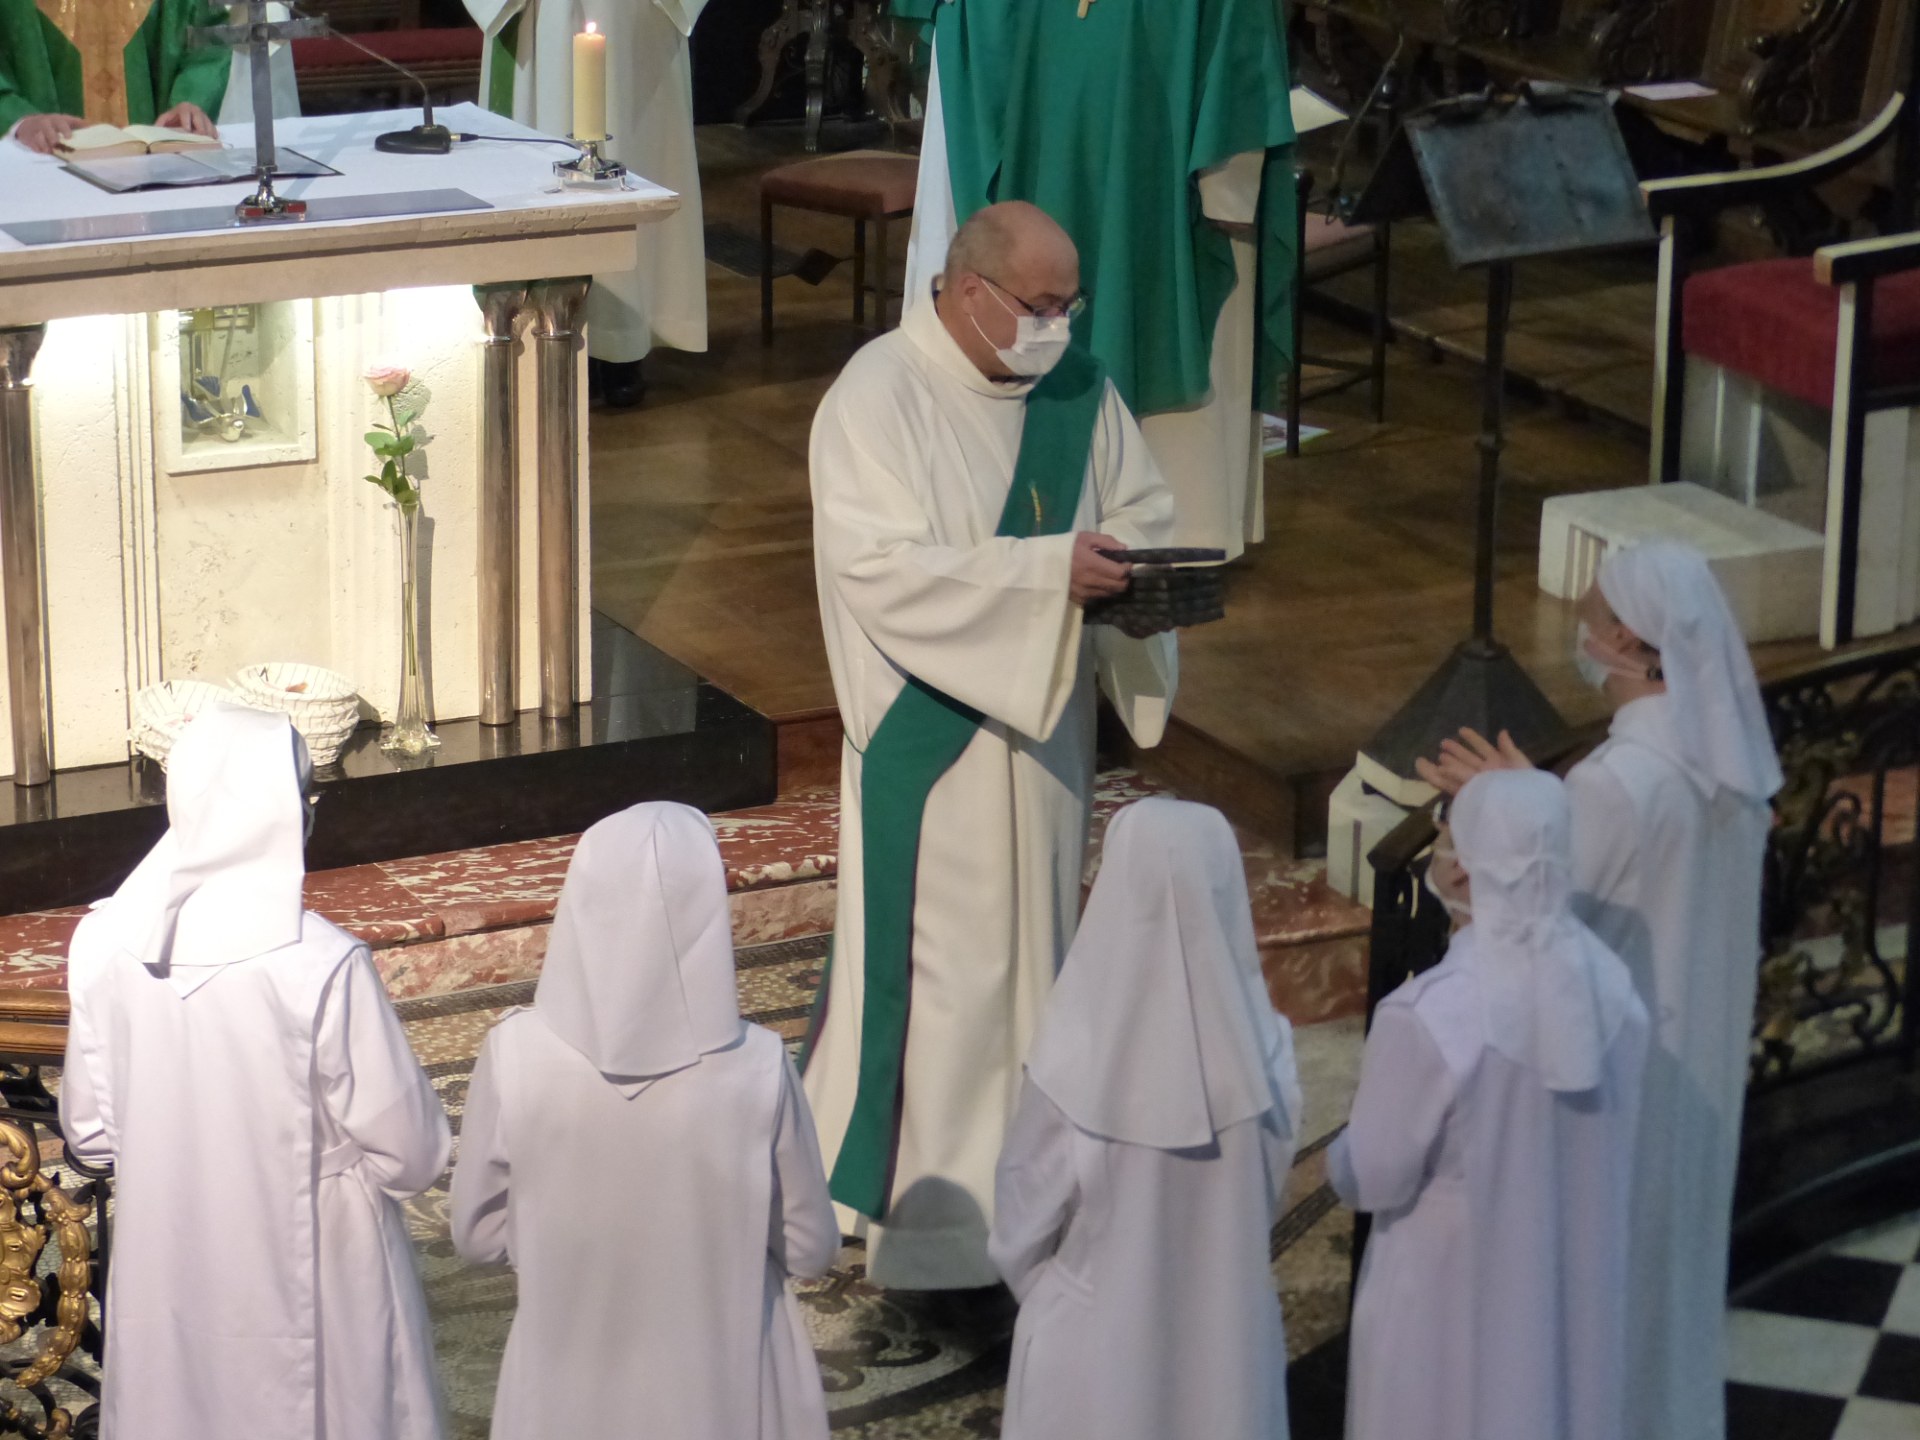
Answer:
1567;543;1780;1440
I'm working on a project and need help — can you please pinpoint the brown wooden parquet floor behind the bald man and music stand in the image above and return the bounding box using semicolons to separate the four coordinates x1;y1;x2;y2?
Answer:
591;131;1866;839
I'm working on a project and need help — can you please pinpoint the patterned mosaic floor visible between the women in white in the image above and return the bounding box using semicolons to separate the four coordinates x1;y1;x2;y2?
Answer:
399;937;1359;1440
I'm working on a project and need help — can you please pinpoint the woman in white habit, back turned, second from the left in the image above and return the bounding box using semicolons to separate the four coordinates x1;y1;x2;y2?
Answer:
453;804;839;1440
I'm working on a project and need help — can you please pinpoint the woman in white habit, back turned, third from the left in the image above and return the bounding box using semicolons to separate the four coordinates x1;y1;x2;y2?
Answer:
991;799;1300;1440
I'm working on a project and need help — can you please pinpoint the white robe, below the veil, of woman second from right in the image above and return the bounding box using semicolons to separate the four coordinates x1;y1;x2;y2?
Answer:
1327;960;1643;1440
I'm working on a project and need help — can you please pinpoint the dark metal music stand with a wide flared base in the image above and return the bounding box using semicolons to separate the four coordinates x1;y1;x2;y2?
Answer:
1342;84;1655;803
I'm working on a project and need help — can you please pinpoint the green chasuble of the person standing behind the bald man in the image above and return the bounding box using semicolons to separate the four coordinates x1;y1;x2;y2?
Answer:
895;0;1298;415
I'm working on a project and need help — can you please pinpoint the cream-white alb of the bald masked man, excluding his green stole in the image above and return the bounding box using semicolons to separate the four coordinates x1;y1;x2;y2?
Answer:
806;305;1177;1288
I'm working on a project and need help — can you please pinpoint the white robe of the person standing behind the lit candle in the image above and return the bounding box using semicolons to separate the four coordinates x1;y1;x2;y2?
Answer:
467;0;707;363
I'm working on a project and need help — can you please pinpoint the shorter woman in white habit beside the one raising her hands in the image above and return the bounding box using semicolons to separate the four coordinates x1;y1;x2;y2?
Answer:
1327;772;1647;1440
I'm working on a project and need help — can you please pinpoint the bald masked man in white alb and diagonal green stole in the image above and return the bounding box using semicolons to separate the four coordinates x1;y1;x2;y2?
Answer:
806;202;1175;1290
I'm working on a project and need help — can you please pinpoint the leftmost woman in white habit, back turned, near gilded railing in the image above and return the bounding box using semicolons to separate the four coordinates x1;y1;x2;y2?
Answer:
60;705;449;1440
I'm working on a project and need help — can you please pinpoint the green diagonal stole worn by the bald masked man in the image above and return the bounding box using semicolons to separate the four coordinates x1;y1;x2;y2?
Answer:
812;348;1106;1219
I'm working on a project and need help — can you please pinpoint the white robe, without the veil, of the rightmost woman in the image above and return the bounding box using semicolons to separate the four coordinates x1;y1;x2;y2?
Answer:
1567;695;1772;1440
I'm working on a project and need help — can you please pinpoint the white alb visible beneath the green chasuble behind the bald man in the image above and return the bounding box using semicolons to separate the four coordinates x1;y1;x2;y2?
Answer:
904;46;1267;559
